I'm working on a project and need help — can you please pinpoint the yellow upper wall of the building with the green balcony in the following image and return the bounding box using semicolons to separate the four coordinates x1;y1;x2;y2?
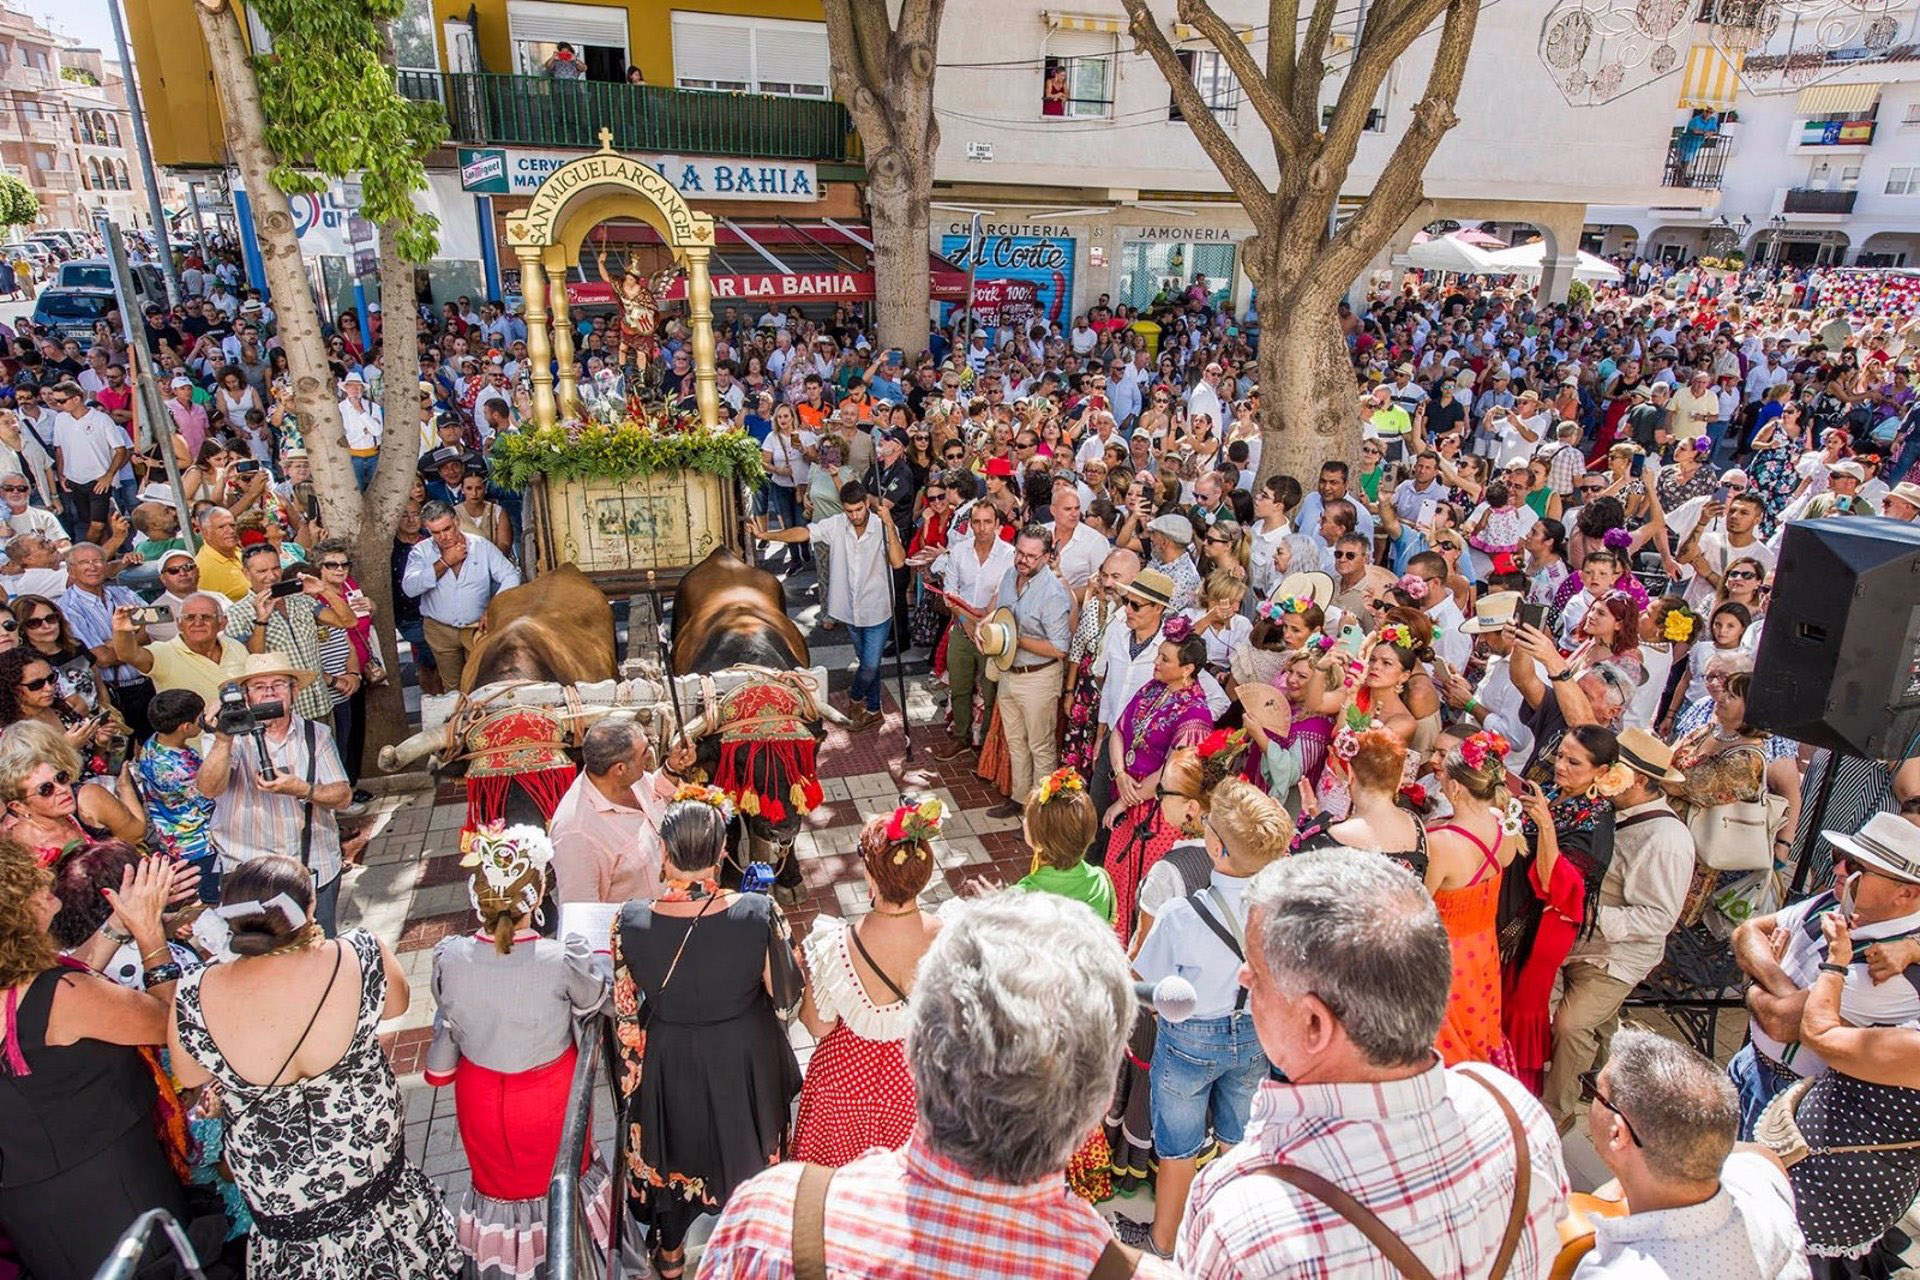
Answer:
127;0;822;165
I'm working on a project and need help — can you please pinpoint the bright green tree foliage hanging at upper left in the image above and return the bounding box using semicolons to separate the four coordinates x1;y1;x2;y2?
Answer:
250;0;447;263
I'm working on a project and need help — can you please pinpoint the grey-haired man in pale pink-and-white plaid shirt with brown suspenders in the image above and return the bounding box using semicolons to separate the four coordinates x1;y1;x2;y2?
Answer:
1175;848;1567;1280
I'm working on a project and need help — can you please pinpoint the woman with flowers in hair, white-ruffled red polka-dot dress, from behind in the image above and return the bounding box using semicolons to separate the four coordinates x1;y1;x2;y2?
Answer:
793;800;943;1169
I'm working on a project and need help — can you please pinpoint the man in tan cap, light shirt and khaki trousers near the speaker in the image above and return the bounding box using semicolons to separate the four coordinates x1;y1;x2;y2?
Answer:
1540;729;1693;1134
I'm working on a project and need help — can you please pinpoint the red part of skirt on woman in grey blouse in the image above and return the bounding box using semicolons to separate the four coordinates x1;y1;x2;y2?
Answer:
453;1046;593;1199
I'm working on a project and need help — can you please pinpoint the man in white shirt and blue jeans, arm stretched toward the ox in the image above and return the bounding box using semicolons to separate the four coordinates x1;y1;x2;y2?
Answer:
749;480;906;733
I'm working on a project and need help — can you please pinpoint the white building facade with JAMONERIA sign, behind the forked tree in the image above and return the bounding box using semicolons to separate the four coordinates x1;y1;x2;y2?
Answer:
931;0;1715;326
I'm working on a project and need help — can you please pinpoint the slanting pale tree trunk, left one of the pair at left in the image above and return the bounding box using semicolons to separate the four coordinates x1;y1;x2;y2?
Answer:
194;0;361;530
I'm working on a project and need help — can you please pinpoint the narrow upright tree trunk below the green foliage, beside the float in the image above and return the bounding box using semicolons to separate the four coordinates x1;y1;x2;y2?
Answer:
359;225;420;773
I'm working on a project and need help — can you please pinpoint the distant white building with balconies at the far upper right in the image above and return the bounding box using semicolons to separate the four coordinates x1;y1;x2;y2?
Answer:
1590;46;1920;267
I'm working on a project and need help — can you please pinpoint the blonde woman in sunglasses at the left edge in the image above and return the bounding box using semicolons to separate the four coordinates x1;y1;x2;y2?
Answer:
0;720;146;865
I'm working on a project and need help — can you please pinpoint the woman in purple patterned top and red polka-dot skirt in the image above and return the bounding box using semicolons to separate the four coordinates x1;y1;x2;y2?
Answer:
1106;618;1213;942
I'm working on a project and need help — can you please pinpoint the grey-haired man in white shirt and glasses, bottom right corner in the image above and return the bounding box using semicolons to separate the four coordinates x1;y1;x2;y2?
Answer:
1574;1029;1811;1280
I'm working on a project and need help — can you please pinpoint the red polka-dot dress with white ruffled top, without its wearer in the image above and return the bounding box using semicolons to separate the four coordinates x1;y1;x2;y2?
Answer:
793;915;914;1169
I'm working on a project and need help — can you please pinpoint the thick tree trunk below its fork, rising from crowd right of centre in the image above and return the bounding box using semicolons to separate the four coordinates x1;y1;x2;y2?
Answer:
1260;288;1359;489
